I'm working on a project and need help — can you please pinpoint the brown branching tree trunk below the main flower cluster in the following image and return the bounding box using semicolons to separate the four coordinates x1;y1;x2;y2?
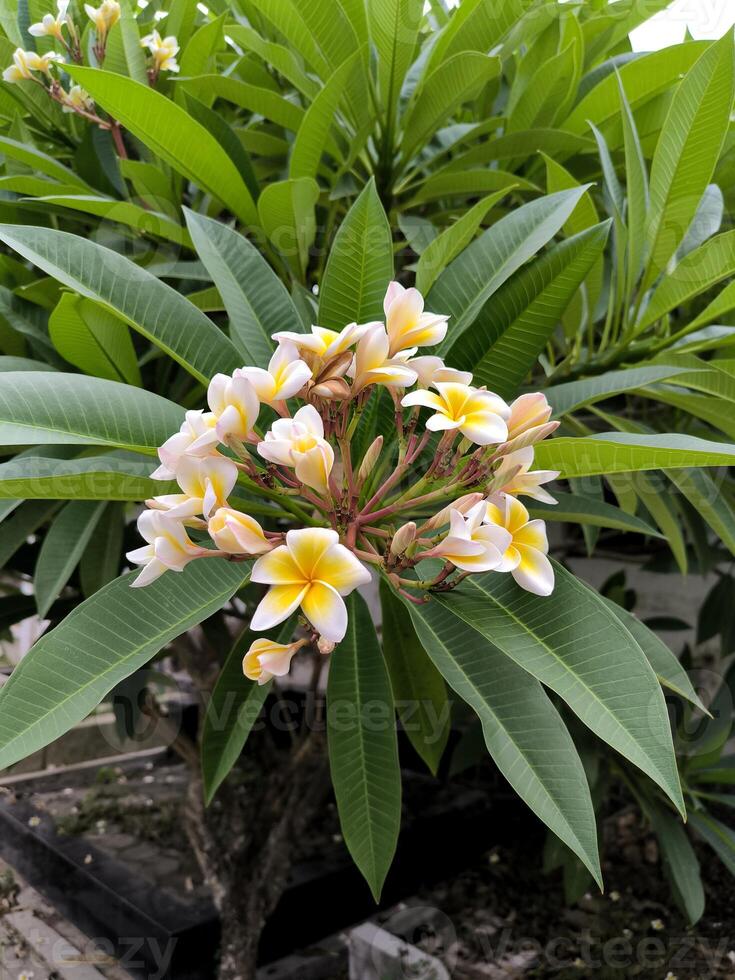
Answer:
186;732;329;980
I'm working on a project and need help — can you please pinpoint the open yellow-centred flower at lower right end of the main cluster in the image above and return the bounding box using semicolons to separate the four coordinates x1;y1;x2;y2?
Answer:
484;494;554;596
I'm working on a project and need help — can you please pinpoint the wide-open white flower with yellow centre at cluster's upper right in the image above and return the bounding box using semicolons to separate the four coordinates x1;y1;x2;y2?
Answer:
401;381;510;446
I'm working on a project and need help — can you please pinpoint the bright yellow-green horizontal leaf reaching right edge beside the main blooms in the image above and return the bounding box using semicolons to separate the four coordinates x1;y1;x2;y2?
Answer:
535;432;735;477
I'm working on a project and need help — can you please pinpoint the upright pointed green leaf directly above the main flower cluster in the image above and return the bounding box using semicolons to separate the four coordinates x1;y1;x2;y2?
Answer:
319;179;393;330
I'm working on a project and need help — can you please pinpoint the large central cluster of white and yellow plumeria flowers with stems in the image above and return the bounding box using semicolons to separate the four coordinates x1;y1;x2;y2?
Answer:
128;282;558;683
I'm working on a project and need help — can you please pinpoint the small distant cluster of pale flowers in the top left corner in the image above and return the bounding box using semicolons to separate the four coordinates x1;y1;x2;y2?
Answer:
3;0;179;116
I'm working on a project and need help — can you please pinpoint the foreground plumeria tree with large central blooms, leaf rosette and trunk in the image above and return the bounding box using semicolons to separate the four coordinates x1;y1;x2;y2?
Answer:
0;178;732;976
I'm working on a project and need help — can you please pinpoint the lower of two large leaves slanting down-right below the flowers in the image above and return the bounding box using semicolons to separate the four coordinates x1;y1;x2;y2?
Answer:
409;599;602;883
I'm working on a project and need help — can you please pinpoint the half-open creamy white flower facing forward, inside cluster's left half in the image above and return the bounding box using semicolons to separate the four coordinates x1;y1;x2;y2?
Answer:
258;405;334;493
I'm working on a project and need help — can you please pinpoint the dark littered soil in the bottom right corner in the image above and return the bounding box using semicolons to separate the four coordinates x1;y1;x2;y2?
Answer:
413;809;735;980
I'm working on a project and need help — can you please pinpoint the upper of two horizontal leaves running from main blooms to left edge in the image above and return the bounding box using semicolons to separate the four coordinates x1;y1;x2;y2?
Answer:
0;371;184;453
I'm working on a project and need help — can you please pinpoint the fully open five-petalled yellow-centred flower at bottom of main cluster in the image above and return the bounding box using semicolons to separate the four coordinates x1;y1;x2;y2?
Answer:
250;527;370;643
